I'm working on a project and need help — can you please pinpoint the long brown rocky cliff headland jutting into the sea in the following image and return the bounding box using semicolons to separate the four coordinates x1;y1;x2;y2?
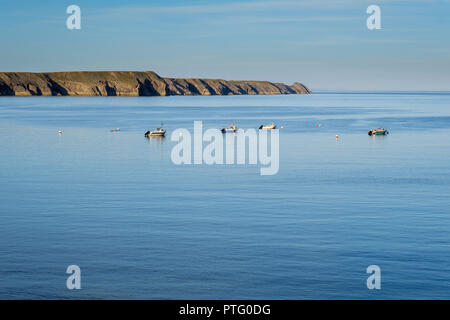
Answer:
0;71;311;96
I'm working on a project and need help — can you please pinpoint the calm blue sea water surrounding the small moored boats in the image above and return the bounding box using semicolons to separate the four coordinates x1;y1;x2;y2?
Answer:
0;92;450;299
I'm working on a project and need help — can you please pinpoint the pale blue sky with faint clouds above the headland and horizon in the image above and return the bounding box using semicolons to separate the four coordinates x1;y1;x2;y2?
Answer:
0;0;450;91
